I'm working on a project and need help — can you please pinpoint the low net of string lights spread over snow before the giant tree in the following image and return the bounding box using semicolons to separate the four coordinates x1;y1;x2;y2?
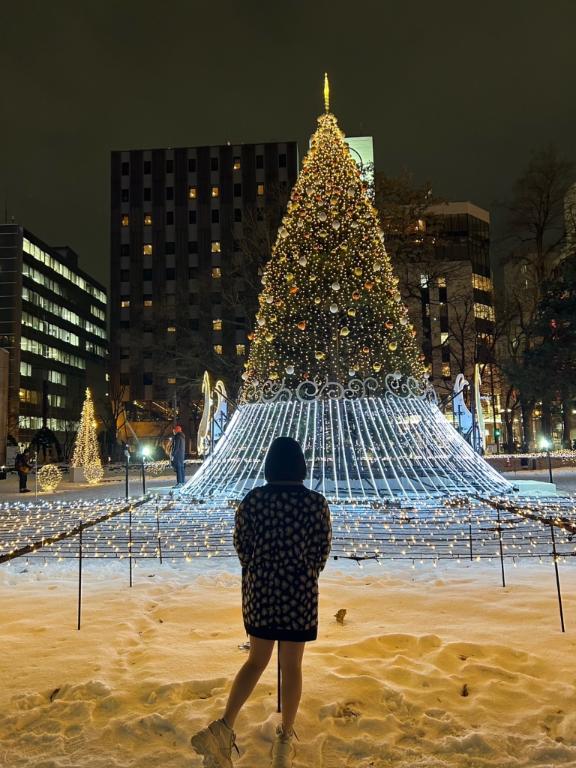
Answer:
0;497;576;565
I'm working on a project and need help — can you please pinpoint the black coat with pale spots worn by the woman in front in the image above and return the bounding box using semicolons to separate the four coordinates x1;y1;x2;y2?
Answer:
234;483;332;642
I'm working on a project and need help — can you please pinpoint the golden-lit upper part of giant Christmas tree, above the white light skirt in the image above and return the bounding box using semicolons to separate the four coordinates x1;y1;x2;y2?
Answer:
243;73;424;388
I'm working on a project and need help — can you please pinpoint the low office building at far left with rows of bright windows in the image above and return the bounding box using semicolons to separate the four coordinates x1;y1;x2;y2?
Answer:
0;224;107;462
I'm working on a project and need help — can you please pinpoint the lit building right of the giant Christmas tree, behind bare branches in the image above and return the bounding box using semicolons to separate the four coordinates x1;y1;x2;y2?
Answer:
399;202;500;450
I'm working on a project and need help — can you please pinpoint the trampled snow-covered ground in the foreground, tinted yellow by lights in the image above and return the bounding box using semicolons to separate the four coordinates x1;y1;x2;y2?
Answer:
0;557;576;768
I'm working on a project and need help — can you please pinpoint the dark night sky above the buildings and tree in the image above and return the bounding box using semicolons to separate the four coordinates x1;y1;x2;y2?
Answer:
0;0;576;288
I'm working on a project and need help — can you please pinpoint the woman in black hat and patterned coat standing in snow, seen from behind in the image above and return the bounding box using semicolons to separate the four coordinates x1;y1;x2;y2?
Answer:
192;437;332;768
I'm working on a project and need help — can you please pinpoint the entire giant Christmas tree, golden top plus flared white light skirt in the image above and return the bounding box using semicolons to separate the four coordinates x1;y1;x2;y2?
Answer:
182;91;512;505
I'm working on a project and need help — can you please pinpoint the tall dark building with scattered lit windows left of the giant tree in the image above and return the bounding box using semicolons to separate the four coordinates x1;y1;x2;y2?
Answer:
110;142;298;448
